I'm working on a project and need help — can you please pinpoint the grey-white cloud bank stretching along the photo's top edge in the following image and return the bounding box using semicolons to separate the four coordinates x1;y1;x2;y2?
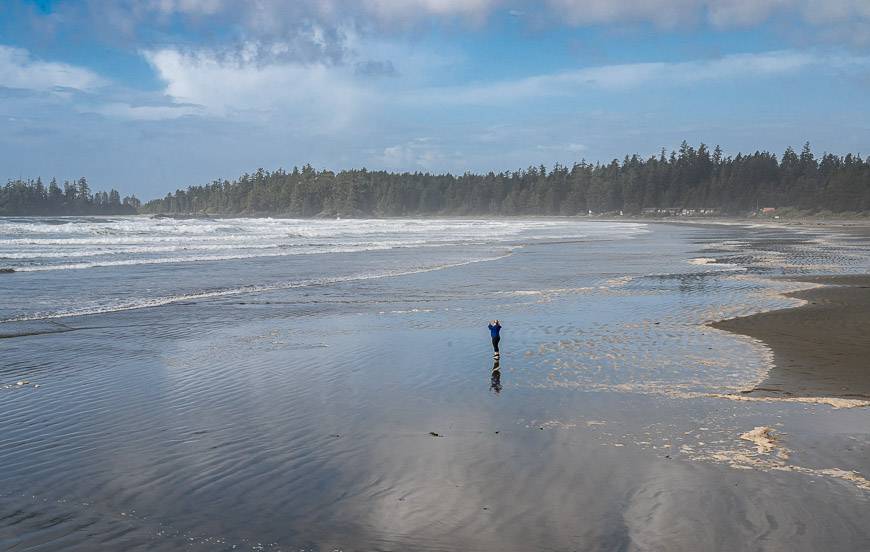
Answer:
17;0;870;44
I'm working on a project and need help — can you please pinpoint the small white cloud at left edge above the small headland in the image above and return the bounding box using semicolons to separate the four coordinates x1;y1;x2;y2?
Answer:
0;46;106;90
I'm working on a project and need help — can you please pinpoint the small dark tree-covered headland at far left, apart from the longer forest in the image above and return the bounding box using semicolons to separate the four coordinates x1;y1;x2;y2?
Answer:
0;177;141;216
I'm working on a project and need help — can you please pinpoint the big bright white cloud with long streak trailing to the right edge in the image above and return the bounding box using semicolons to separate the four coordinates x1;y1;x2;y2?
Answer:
141;43;870;127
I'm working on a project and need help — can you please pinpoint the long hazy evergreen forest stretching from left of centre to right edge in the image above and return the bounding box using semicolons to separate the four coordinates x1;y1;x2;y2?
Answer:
140;142;870;217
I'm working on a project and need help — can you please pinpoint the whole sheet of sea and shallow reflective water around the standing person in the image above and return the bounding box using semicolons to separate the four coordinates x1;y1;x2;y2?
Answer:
0;218;870;550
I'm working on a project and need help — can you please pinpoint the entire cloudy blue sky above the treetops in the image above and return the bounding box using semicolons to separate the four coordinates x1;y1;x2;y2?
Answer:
0;0;870;199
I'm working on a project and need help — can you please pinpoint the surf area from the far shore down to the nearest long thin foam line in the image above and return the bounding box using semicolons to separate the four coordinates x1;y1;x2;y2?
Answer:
0;216;647;322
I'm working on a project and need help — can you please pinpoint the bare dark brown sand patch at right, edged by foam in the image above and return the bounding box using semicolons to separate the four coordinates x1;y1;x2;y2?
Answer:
712;275;870;398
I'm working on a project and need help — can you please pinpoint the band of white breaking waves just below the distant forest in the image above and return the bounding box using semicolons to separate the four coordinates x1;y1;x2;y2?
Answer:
0;216;646;272
